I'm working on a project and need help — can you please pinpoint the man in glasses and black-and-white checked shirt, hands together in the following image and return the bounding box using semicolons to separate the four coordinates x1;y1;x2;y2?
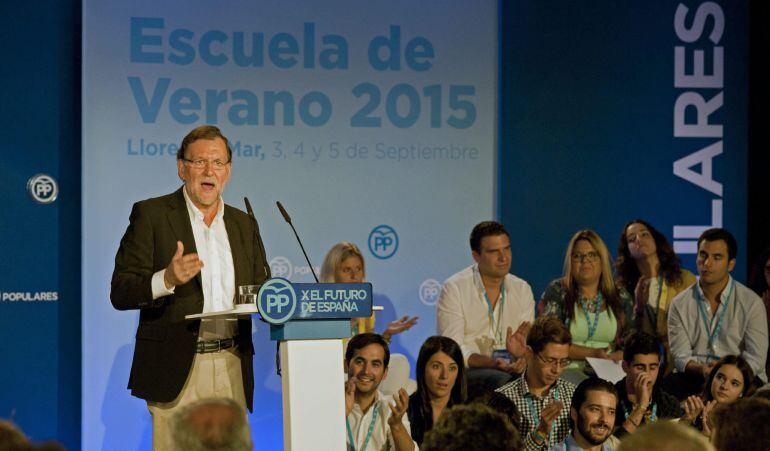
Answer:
497;316;575;450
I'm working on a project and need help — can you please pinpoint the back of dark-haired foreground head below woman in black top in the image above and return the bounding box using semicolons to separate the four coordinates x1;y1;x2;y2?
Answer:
420;403;522;451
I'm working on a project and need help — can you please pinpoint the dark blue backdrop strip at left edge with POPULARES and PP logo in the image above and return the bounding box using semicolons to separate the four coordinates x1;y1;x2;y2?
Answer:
0;0;80;449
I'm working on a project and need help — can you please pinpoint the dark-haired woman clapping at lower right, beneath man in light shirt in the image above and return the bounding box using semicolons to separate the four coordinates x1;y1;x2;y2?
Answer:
680;355;755;437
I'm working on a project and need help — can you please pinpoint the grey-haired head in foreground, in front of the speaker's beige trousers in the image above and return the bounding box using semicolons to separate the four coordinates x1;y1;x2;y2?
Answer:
171;398;252;451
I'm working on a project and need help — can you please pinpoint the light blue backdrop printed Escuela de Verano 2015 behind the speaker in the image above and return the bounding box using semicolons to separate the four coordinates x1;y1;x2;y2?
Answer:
83;0;498;449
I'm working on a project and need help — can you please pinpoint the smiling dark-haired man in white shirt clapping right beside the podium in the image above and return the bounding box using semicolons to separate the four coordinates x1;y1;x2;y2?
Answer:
345;332;415;451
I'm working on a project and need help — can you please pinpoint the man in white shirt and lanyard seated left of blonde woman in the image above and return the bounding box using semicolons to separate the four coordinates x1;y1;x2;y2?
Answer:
437;221;535;392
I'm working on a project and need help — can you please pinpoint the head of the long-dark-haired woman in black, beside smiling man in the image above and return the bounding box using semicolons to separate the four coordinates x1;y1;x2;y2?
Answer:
415;335;467;407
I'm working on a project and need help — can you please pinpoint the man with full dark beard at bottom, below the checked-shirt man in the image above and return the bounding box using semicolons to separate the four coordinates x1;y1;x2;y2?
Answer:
549;377;618;451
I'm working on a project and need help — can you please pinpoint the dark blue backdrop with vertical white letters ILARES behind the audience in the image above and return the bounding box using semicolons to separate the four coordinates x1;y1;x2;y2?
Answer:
499;1;748;297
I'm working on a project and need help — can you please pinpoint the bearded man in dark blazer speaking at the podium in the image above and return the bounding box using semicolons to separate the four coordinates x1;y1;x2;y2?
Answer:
110;126;269;449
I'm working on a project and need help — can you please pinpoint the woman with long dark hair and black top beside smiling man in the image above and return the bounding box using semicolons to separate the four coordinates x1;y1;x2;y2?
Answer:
407;335;466;445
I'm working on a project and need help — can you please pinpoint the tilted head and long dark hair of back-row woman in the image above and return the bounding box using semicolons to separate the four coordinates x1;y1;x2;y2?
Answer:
615;219;682;292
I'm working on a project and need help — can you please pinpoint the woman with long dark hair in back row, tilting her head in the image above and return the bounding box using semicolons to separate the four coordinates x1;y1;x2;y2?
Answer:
615;219;695;373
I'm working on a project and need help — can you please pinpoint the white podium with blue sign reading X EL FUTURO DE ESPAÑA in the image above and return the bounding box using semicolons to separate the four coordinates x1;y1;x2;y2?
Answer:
254;278;372;451
